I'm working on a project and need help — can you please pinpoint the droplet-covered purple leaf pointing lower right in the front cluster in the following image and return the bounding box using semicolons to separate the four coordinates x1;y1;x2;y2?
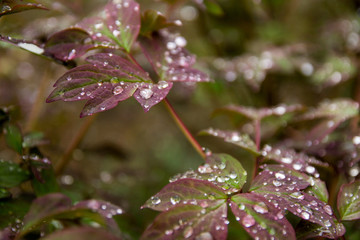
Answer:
250;170;337;234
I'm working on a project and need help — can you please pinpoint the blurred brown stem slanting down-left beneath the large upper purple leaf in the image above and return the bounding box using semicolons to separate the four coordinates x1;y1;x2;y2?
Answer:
55;114;97;175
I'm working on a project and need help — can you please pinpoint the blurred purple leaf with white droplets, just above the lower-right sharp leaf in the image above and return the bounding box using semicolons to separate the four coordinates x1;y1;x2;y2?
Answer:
261;145;328;177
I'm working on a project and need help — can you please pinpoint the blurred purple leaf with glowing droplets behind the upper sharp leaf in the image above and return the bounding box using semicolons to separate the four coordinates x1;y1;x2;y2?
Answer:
141;31;210;82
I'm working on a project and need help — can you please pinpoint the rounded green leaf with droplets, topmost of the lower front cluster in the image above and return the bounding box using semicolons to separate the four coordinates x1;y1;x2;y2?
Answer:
170;154;247;194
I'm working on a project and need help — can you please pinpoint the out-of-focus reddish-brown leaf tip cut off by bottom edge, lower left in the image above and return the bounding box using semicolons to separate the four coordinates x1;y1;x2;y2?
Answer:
42;227;120;240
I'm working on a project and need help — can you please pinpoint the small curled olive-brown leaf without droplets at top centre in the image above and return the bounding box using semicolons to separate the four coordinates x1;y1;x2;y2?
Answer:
140;9;177;37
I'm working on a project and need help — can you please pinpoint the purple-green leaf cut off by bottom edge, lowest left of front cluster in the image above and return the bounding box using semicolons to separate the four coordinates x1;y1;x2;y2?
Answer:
141;200;228;240
